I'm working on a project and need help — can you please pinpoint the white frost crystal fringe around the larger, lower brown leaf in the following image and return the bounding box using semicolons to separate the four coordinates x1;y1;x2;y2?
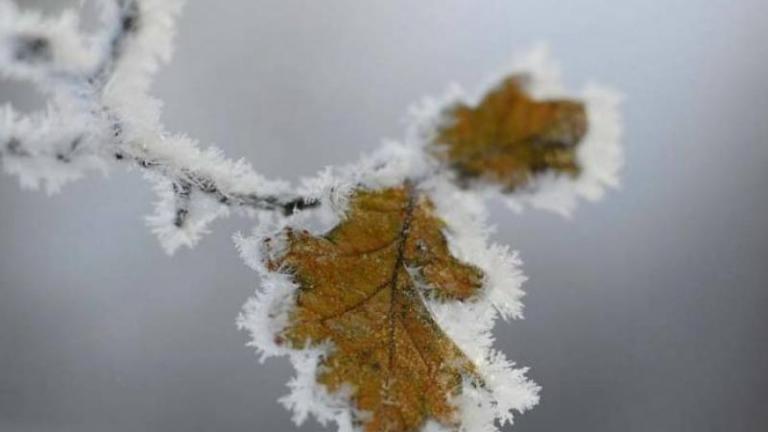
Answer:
236;169;539;431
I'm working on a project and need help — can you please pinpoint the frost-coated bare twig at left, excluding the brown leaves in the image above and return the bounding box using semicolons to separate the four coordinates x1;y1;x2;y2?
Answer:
0;0;319;252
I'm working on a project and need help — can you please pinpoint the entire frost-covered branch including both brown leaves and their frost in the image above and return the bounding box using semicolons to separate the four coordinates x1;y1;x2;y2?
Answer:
0;0;622;432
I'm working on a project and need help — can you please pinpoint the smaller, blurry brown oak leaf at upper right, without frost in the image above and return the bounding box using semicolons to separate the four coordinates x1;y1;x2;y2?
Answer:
432;75;587;191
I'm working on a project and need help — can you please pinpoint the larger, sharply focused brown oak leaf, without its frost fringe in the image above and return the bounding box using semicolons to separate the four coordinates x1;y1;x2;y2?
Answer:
268;183;483;432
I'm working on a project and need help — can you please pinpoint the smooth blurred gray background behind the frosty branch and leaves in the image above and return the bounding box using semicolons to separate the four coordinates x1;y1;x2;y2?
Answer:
0;0;768;432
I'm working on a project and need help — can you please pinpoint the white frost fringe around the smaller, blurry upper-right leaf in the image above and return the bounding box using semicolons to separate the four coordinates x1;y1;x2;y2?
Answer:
406;44;624;217
